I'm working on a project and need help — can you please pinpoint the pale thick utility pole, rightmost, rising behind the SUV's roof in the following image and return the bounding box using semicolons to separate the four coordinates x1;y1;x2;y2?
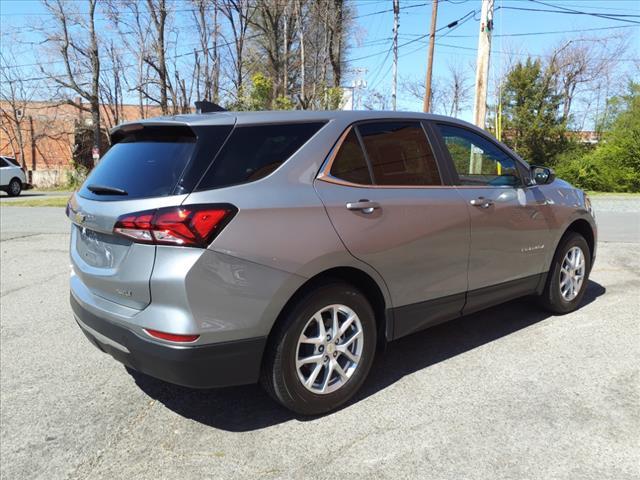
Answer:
473;0;494;128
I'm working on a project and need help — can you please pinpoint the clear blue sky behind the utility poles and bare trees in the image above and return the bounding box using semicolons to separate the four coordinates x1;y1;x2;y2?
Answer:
0;0;640;124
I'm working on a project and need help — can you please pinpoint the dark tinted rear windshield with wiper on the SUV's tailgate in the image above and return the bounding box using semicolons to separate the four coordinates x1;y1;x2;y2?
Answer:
80;126;231;200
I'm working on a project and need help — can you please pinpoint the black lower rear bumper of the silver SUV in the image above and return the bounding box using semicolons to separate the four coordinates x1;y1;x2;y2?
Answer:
71;294;266;388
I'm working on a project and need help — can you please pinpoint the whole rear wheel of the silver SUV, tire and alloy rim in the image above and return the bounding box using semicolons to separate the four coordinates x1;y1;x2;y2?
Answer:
261;283;376;415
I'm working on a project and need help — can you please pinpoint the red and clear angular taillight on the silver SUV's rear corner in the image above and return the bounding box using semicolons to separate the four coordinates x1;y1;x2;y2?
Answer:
113;204;237;248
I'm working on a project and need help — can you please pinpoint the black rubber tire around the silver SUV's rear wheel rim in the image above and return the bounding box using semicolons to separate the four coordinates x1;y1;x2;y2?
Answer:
260;281;377;415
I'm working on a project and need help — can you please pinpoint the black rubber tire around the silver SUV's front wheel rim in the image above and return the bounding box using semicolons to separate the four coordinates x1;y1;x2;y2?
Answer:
540;232;591;315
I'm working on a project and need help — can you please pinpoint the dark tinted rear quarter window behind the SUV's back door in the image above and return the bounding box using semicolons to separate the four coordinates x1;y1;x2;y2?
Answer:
198;123;324;190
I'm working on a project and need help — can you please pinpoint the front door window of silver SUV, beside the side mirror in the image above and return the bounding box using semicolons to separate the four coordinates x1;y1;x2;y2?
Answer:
438;125;521;187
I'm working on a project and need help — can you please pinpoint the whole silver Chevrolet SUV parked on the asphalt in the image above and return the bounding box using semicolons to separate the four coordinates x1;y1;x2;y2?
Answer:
67;112;596;414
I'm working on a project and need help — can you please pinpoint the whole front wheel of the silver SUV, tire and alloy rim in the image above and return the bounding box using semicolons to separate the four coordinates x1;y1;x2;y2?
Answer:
541;232;591;314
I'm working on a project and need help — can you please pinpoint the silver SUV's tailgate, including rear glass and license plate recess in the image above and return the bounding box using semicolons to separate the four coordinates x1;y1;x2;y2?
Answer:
67;120;232;309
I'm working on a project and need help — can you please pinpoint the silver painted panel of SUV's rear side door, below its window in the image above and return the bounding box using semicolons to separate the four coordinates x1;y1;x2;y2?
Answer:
316;180;469;307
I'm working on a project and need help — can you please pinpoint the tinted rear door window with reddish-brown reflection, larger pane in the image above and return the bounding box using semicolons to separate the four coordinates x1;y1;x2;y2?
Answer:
358;122;442;185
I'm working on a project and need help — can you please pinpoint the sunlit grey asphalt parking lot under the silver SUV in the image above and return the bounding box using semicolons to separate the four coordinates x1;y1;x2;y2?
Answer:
0;198;640;480
